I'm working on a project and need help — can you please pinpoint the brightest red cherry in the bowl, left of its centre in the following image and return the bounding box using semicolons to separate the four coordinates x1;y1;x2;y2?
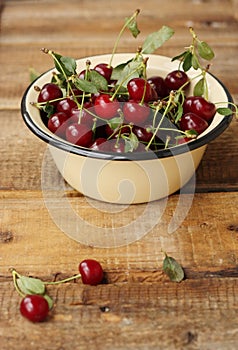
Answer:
94;94;120;119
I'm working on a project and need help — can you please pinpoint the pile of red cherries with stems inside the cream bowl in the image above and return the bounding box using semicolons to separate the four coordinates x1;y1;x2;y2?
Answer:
38;63;216;153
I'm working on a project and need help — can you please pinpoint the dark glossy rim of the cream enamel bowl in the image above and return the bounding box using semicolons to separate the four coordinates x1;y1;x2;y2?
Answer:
21;69;233;161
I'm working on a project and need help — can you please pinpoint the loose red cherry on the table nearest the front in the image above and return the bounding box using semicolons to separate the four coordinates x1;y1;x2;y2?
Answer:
20;294;49;322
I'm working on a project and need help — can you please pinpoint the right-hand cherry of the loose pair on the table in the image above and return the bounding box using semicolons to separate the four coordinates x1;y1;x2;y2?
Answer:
79;259;104;286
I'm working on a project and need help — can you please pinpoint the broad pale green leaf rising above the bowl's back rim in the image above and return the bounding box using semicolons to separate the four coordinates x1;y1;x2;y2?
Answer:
142;26;174;54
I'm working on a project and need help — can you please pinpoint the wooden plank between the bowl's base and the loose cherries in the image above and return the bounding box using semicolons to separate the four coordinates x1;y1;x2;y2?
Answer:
0;191;238;282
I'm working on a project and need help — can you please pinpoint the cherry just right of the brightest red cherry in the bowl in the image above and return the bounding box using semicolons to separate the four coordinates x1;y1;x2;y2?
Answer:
123;101;150;126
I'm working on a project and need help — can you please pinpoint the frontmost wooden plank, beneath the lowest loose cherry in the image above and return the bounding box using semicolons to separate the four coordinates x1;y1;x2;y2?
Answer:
0;278;238;350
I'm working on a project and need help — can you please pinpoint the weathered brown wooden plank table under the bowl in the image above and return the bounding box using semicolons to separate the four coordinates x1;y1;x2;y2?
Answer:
0;0;238;350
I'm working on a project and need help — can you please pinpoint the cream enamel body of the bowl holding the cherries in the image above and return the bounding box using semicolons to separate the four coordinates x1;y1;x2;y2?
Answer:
21;53;232;204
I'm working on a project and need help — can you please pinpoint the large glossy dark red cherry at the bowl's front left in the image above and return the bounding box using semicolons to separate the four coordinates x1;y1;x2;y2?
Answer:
66;123;93;147
